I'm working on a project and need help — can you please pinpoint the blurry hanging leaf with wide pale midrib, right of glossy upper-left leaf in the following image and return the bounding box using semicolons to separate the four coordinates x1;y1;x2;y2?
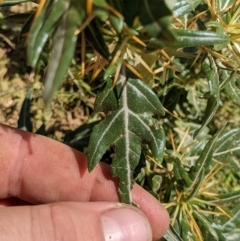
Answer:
43;0;85;104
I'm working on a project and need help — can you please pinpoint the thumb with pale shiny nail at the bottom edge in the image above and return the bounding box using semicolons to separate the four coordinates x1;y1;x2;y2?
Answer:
0;202;152;241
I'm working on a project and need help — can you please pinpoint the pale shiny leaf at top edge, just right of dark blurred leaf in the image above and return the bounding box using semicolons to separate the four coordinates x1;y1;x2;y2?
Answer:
173;0;202;17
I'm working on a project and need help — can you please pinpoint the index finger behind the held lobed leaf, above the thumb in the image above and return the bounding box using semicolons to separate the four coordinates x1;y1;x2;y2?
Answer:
0;125;169;237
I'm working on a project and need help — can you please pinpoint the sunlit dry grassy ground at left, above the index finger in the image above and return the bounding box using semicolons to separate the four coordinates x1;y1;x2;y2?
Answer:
0;8;97;141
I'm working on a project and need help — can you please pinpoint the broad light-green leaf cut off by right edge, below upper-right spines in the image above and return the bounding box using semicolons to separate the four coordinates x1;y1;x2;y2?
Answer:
224;72;240;106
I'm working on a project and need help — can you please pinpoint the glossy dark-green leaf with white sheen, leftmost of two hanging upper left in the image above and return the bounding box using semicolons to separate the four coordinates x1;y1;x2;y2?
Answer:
27;0;69;67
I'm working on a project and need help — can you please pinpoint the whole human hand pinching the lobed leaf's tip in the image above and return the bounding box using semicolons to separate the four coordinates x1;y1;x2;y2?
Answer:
0;125;169;241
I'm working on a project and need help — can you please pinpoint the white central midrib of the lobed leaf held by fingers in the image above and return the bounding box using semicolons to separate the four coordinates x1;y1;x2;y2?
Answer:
120;71;132;203
